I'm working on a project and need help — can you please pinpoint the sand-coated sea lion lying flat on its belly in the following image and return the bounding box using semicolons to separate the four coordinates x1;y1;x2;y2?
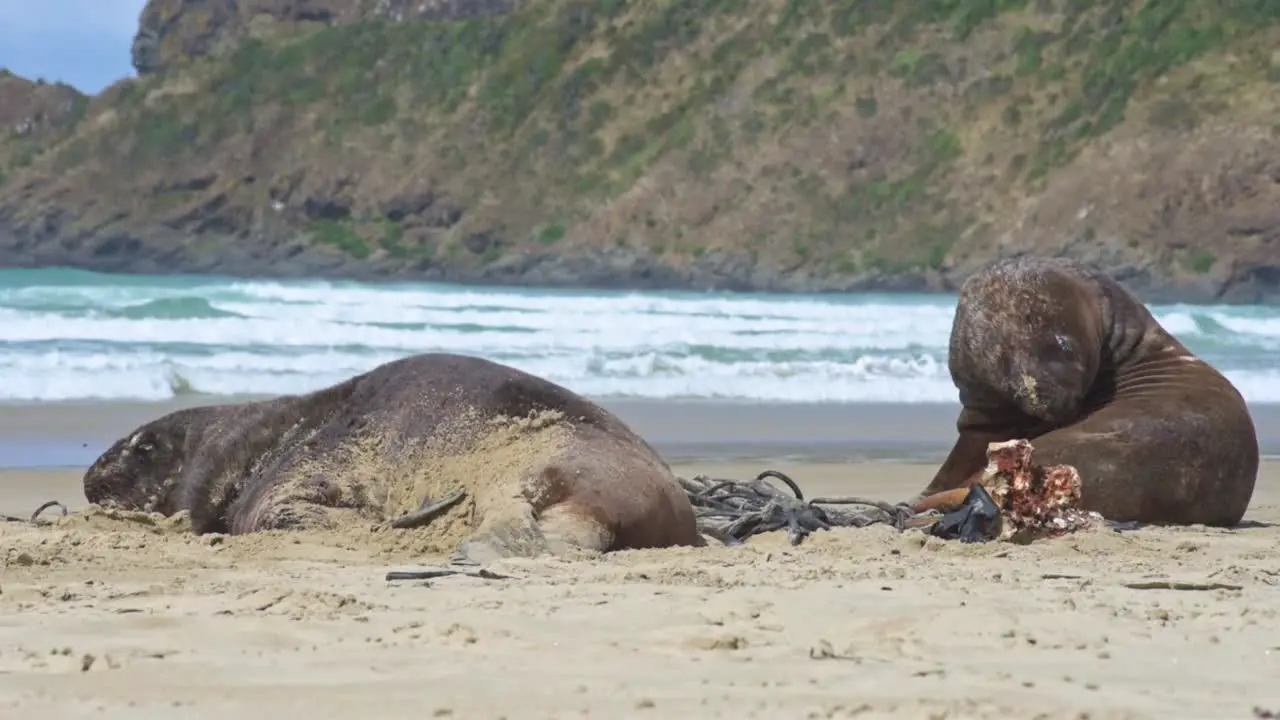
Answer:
83;354;701;562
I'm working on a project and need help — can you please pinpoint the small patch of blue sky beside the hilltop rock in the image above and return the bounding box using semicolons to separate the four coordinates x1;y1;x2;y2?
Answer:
0;0;146;92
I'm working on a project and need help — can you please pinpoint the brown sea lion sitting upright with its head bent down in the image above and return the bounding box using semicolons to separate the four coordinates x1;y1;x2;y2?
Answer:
915;258;1258;527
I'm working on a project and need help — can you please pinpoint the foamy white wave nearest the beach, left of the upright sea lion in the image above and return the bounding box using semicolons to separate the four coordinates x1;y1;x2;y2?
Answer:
0;351;955;402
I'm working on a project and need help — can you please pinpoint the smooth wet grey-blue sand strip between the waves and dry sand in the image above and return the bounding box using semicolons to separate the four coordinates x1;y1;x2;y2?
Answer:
12;396;1280;469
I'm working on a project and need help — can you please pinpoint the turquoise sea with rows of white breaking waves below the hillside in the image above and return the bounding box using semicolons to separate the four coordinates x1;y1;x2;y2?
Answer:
0;270;1280;402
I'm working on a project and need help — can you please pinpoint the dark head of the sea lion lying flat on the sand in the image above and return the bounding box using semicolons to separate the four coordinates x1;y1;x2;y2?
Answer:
83;418;183;515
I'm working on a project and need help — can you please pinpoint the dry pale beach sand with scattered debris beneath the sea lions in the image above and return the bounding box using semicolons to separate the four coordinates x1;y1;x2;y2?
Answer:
0;462;1280;720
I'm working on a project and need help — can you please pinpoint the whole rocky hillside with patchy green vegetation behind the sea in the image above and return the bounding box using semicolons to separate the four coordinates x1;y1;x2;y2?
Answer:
0;0;1280;302
